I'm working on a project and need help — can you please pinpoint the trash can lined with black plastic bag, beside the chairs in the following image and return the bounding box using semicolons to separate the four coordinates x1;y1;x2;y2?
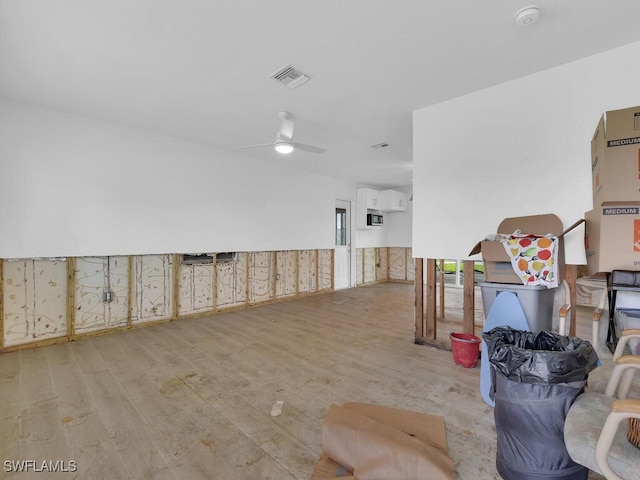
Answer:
482;327;599;480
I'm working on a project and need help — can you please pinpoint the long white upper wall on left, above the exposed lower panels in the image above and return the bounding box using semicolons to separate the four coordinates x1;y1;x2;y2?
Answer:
0;99;355;258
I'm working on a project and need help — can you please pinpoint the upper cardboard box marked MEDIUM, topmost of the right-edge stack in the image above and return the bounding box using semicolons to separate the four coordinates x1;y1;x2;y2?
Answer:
591;106;640;207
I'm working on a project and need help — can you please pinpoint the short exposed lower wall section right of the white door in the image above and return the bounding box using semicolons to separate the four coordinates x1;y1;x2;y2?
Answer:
356;247;415;285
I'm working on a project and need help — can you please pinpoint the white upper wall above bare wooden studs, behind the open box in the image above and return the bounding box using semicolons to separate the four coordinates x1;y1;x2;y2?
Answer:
413;43;640;264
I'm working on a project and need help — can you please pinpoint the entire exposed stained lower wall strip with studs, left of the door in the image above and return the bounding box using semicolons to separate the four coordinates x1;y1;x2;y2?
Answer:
0;249;333;352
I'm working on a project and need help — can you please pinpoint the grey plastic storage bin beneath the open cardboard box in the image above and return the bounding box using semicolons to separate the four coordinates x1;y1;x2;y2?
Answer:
479;282;556;332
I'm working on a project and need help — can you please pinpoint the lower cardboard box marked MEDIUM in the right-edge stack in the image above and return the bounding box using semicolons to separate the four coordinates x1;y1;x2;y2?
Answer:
584;202;640;275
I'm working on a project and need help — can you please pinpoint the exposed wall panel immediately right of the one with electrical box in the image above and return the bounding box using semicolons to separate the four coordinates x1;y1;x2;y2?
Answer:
131;255;173;324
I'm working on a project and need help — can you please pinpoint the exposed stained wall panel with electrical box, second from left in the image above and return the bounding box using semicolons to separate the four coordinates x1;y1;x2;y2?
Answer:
73;256;129;334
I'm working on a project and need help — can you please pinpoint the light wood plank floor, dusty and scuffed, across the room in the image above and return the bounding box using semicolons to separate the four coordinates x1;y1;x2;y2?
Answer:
0;283;628;480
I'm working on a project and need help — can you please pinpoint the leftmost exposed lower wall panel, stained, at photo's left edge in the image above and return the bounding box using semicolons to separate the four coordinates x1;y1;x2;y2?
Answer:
2;259;67;347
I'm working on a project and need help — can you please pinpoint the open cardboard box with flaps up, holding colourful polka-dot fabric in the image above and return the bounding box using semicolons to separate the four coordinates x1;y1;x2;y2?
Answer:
469;213;584;285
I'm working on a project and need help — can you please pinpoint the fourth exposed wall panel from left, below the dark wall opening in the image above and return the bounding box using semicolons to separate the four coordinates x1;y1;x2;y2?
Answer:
178;262;214;315
